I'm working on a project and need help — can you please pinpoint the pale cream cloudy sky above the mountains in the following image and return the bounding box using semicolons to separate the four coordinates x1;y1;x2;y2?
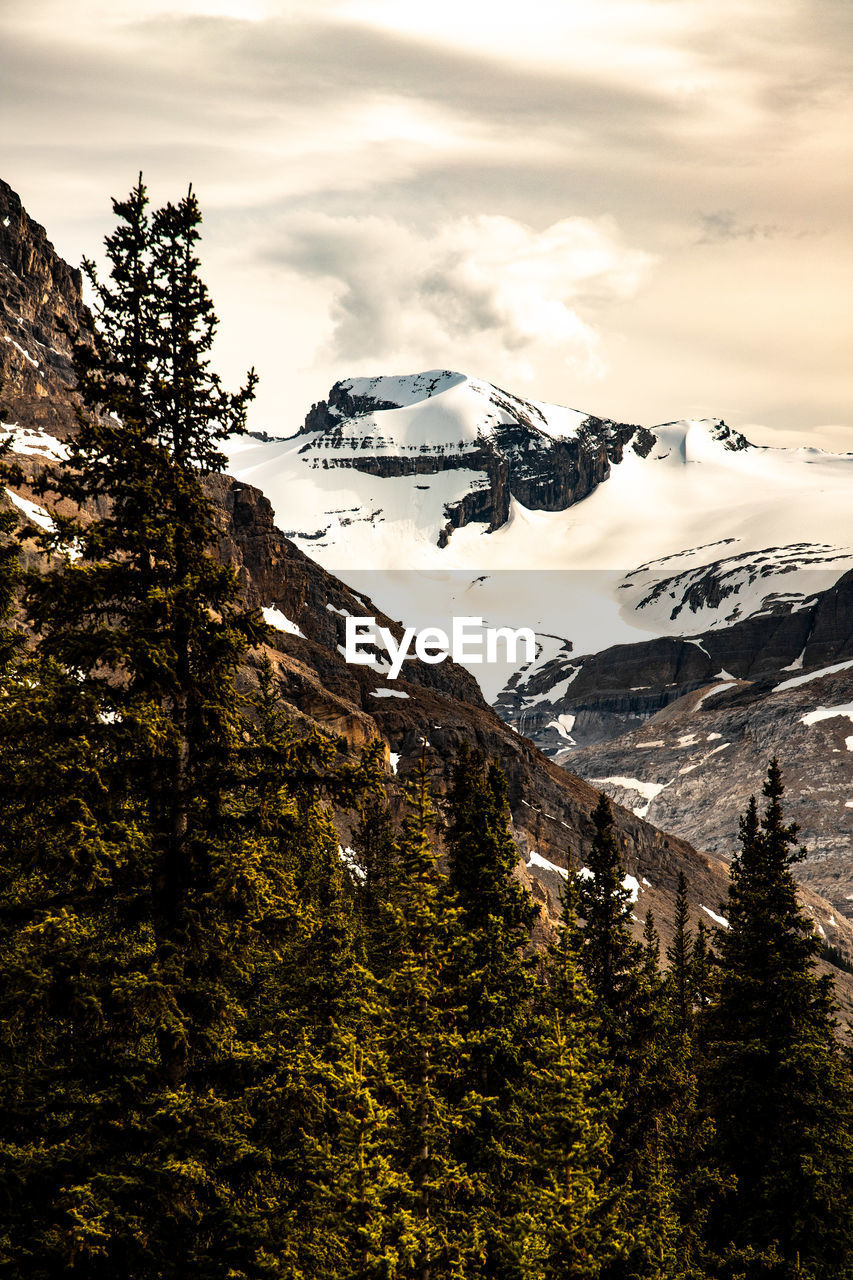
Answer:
0;0;853;449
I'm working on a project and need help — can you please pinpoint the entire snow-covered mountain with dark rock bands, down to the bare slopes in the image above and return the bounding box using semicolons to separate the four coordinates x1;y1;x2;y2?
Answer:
229;371;853;694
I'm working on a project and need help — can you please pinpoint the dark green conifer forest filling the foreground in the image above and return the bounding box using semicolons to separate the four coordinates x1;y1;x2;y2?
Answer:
0;179;853;1280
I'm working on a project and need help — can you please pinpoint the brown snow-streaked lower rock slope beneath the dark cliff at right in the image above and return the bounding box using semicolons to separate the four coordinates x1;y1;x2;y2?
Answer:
566;659;853;918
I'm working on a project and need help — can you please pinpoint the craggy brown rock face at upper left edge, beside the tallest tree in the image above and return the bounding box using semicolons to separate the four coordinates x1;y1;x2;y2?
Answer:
0;180;91;439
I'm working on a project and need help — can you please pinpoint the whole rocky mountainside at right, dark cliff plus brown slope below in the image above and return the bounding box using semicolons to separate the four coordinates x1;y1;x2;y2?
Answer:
498;573;853;918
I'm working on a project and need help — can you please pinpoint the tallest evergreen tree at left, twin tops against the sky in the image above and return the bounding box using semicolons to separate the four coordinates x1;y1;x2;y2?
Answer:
28;180;265;1084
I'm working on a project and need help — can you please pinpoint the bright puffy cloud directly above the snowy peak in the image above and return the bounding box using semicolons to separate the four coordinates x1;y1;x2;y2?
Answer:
273;214;652;378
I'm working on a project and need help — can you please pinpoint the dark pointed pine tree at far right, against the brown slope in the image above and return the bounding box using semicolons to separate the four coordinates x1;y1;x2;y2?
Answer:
707;760;853;1280
